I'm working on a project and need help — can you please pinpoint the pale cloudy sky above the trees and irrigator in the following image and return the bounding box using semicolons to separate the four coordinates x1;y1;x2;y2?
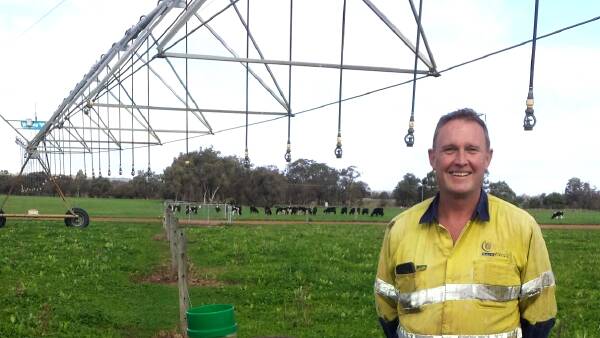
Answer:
0;0;600;195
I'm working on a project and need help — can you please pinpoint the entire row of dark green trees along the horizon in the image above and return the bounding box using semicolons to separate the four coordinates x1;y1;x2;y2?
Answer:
0;148;600;210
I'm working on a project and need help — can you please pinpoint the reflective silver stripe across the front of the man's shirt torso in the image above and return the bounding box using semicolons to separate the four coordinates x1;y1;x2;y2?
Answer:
398;284;521;309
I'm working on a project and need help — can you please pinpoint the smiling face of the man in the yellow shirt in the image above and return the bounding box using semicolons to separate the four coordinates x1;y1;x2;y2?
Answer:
429;119;492;199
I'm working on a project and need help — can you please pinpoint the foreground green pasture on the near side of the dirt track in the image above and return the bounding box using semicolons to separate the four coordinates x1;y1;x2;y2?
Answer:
0;220;600;338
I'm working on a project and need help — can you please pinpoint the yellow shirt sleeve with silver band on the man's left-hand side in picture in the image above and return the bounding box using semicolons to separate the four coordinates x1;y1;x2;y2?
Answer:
375;226;398;331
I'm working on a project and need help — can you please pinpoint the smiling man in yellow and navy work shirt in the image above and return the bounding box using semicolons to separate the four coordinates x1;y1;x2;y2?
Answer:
375;109;556;338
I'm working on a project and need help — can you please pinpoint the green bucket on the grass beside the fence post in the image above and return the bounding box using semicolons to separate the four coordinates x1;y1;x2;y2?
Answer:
186;304;237;338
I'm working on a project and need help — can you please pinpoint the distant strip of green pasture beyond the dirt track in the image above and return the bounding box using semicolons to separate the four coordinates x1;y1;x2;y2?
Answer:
0;195;600;224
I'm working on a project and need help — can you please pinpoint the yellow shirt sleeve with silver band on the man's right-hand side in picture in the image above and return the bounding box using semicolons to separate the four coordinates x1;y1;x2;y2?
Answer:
519;220;556;337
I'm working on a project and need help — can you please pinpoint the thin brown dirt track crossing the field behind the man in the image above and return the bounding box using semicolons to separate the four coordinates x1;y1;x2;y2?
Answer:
91;217;600;230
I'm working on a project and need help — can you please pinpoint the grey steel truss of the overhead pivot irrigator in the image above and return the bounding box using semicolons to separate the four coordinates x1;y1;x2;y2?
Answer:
0;0;439;224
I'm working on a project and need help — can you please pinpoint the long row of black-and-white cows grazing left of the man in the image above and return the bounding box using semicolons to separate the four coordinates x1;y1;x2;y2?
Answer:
168;204;384;217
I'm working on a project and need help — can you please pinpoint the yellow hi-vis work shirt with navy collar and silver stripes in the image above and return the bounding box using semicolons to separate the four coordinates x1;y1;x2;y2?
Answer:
375;190;556;338
